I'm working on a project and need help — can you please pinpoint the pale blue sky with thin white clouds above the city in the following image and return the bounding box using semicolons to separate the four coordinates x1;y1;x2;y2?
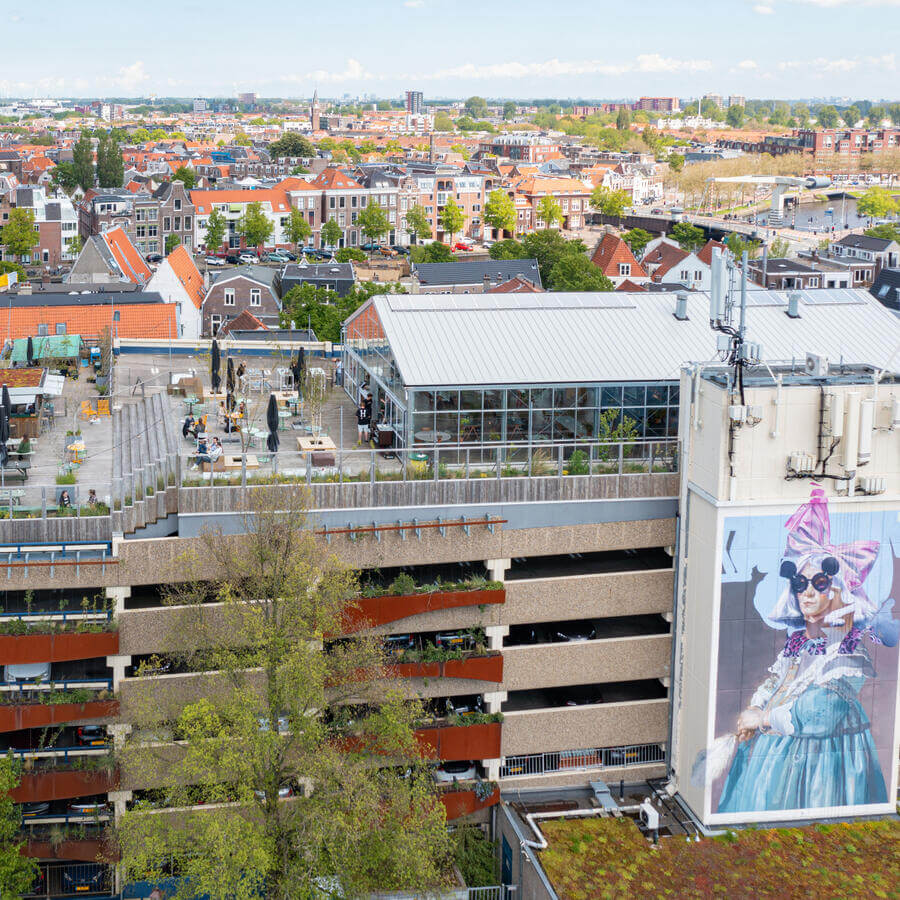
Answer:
0;0;900;100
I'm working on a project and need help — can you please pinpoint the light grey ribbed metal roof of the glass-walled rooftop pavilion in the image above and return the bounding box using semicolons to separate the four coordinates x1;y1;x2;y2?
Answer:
368;289;900;387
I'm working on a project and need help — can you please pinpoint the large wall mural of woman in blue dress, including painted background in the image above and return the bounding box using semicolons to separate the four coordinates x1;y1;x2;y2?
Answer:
703;485;900;819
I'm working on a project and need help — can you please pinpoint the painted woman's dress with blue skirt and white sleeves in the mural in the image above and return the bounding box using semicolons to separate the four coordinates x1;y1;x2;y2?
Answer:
716;629;887;813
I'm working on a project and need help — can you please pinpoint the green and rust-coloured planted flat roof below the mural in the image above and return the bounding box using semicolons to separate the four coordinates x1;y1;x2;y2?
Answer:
540;819;900;900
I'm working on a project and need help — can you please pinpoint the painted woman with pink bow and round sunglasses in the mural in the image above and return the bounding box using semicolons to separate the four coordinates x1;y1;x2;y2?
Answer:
718;487;897;813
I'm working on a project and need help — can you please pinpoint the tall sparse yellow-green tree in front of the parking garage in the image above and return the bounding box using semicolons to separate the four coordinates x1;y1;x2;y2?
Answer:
119;486;450;900
